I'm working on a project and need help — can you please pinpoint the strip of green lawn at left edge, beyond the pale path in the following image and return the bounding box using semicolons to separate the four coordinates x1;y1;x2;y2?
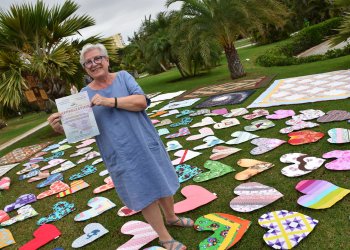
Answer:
0;112;48;145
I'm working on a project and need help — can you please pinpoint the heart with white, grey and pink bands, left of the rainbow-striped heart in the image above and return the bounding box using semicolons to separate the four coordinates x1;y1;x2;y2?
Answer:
230;182;283;213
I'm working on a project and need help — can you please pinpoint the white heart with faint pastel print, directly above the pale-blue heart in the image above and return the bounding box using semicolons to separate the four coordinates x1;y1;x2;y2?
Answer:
74;197;115;221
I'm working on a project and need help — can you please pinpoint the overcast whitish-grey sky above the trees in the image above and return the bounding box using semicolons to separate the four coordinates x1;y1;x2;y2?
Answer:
0;0;181;43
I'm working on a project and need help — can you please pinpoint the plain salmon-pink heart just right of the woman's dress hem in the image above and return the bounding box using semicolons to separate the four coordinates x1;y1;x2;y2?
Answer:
174;185;217;214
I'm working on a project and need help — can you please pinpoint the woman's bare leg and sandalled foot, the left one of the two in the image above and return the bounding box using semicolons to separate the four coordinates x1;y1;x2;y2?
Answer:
142;201;186;249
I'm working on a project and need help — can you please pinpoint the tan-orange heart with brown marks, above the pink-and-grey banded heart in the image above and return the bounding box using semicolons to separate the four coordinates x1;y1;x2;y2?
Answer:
235;159;275;181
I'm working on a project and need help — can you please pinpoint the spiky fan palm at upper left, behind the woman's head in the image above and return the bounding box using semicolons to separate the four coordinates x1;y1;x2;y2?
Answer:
0;0;115;109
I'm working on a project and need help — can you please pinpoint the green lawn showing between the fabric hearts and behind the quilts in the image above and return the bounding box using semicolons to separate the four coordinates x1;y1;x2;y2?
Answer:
0;40;350;250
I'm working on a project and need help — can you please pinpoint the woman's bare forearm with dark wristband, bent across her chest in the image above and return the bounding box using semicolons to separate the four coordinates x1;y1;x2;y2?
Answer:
91;94;147;111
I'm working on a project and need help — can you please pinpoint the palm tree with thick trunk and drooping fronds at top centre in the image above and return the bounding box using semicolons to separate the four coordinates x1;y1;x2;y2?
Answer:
166;0;287;79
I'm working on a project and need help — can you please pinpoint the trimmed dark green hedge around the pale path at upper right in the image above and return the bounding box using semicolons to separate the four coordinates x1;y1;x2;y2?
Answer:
256;17;346;67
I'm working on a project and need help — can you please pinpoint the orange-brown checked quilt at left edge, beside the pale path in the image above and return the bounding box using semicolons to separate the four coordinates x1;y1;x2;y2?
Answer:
0;142;51;166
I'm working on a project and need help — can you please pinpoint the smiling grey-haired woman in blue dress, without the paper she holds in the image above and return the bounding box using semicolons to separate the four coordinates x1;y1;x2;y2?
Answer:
48;44;193;250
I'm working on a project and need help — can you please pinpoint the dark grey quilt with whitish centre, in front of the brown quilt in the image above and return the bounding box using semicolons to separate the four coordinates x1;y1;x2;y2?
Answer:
195;90;255;108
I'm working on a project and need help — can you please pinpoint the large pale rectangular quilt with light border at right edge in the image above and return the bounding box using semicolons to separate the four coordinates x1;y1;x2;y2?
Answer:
248;70;350;108
